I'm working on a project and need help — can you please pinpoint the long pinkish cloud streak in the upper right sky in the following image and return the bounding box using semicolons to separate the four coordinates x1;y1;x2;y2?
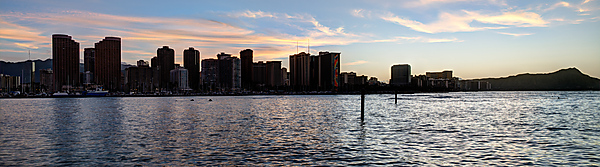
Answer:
380;10;548;33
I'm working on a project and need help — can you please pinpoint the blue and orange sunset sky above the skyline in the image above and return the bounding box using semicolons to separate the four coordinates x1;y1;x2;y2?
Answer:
0;0;600;82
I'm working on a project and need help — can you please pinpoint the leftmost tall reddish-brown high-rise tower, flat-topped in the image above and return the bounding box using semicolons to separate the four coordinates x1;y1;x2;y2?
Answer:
52;34;80;91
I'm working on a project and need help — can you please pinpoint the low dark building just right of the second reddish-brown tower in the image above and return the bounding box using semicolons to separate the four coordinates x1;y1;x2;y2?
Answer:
125;60;153;93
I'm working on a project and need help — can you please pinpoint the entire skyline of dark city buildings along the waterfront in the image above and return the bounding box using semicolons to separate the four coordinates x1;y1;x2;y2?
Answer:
0;34;491;93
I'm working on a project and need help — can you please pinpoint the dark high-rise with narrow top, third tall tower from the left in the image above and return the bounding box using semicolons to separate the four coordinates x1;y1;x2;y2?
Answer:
153;46;175;89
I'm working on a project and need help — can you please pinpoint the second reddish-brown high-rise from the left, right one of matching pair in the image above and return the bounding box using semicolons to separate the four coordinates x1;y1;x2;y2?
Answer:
93;37;121;91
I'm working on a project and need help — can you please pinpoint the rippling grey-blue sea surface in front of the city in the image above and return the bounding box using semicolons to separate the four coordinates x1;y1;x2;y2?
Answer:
0;91;600;166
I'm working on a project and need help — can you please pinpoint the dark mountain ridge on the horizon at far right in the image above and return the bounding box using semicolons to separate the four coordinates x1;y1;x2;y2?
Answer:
474;68;600;90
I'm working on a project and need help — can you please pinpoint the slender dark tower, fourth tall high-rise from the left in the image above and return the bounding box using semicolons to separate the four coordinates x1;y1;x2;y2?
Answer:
183;47;200;90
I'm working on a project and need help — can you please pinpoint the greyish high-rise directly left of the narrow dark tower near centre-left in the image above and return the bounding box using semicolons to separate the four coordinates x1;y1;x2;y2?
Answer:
217;53;241;89
